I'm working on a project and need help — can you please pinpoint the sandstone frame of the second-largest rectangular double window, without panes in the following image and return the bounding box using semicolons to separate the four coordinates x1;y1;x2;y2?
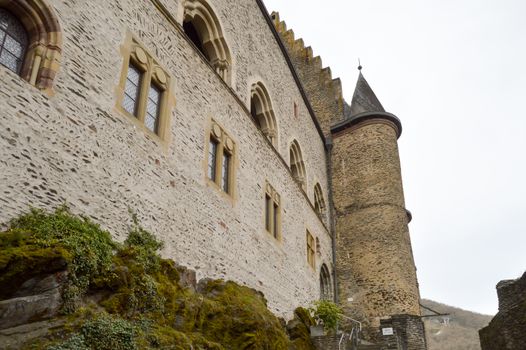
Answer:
204;119;237;199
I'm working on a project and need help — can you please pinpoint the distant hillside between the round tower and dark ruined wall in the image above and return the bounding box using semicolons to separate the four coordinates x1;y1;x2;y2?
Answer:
422;299;493;350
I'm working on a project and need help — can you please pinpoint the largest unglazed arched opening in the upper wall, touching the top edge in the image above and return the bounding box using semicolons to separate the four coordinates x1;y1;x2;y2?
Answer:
183;0;232;83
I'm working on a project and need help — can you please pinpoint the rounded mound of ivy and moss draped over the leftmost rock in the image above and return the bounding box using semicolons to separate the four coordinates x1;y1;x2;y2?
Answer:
0;207;116;309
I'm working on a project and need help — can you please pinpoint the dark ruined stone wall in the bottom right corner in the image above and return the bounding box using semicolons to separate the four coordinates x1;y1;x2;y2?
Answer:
479;273;526;350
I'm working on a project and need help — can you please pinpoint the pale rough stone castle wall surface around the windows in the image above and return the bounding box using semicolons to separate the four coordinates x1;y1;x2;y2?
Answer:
0;0;332;317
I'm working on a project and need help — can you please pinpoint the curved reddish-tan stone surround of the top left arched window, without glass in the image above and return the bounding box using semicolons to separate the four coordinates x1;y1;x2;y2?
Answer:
0;0;62;95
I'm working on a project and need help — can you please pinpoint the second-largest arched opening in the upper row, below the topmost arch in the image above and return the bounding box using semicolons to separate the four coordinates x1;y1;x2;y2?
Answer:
250;82;278;146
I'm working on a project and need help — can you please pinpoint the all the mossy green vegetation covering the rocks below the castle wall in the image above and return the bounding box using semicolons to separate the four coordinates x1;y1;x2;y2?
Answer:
0;207;313;350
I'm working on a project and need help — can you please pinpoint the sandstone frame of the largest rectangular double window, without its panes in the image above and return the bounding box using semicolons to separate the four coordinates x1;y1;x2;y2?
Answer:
115;31;175;142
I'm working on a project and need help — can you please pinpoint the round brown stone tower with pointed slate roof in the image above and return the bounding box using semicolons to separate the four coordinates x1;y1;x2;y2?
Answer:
331;72;423;344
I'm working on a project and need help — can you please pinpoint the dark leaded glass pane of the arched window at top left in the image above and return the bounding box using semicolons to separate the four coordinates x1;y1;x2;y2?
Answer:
0;8;28;74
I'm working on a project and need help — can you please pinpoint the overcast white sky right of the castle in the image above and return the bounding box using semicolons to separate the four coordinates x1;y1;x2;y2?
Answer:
264;0;526;314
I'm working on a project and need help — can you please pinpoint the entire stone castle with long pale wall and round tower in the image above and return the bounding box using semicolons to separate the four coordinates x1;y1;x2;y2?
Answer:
0;0;425;349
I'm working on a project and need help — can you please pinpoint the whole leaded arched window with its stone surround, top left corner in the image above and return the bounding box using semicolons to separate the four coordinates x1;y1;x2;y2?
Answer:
0;0;62;90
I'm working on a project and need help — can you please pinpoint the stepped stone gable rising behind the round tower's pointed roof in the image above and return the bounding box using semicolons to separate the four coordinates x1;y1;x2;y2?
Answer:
271;12;344;136
